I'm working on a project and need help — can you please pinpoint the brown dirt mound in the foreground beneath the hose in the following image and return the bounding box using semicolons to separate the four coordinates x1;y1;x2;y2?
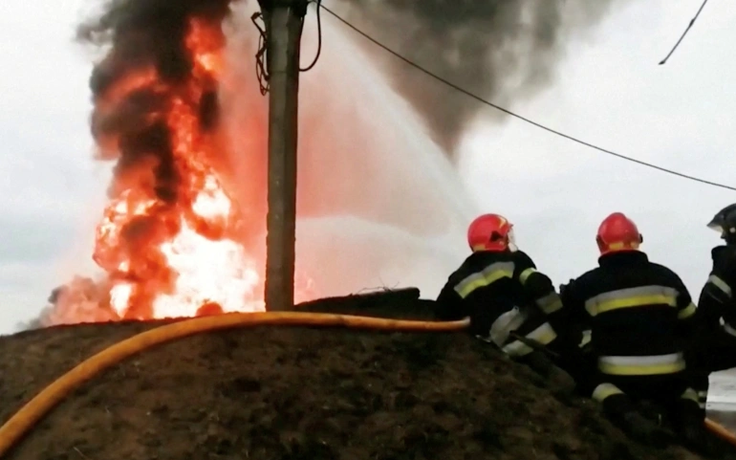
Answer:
0;294;728;460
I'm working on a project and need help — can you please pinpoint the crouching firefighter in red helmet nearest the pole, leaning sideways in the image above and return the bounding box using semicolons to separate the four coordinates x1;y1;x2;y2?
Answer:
436;214;573;391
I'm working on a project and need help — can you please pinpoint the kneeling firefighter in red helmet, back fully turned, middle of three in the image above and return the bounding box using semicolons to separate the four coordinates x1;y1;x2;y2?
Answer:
562;213;707;450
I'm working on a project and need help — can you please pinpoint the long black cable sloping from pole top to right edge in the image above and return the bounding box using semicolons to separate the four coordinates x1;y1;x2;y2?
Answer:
321;5;736;191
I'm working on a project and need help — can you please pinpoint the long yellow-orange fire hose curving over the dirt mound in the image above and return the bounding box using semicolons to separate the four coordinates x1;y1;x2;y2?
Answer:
0;312;470;456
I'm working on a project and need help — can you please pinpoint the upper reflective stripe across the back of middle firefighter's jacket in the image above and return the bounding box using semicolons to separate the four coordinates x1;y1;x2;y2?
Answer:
585;285;678;316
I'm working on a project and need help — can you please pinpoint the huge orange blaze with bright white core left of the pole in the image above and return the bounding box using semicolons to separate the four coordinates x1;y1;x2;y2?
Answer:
46;11;314;324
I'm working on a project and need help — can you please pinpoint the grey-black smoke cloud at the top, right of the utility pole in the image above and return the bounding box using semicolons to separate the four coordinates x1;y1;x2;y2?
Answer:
336;0;627;155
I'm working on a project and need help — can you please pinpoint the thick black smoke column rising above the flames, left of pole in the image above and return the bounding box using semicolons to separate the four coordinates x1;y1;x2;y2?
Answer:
77;0;230;202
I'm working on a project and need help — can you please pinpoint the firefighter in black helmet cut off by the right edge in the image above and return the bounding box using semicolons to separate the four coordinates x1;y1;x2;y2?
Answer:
691;204;736;409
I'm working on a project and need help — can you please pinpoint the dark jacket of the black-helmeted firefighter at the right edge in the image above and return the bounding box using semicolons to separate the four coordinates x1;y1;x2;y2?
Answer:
698;245;736;332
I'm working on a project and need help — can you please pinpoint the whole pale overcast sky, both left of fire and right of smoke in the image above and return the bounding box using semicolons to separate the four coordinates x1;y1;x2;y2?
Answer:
0;0;736;333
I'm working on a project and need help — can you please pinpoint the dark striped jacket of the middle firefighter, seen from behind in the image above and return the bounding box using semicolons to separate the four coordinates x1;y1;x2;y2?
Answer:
562;251;697;375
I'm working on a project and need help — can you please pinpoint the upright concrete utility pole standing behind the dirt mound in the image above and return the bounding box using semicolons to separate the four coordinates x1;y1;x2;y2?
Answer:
259;0;308;311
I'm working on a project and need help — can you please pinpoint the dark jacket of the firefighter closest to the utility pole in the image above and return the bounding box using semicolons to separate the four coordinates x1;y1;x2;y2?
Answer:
436;251;562;334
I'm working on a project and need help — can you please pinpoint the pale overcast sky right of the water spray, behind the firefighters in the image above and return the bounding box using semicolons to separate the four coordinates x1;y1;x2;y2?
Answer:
461;0;736;297
